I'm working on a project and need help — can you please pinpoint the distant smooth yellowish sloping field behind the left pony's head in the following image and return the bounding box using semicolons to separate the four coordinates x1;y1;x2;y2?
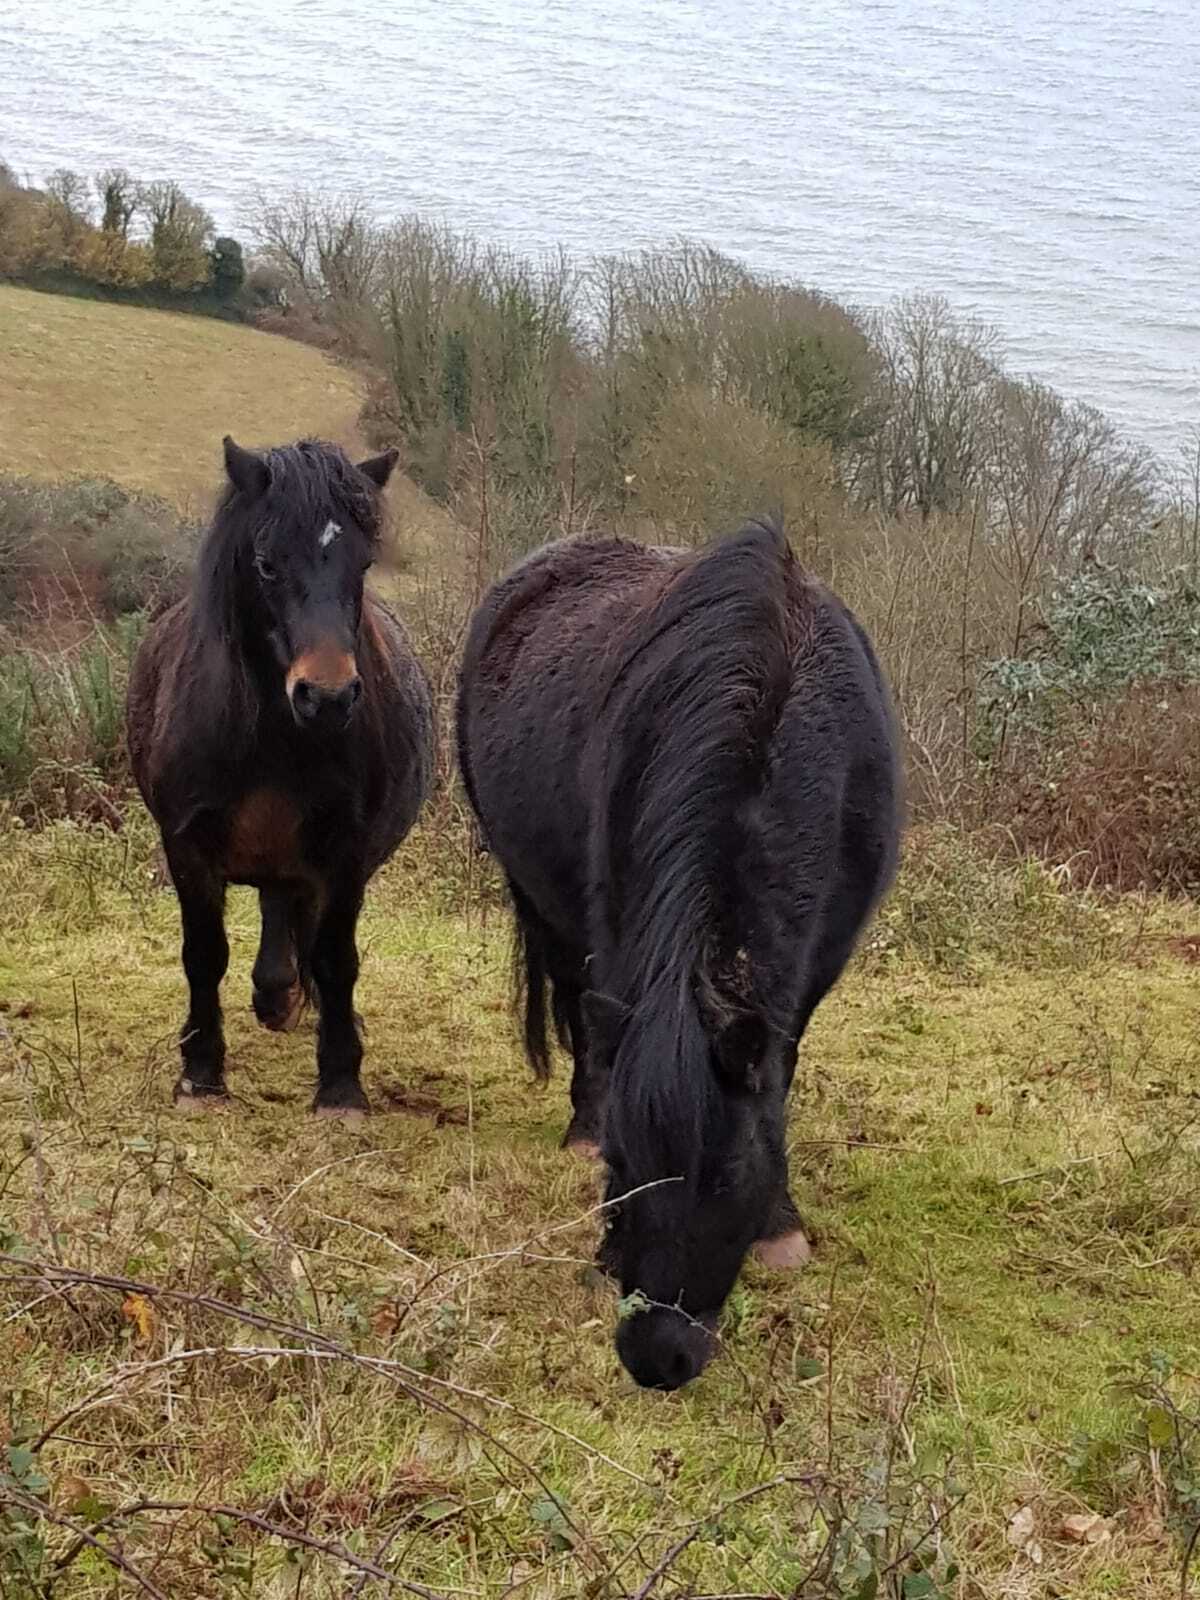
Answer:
0;285;360;514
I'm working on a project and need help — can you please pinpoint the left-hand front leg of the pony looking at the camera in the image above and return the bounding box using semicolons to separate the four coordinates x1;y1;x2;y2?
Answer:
168;853;229;1102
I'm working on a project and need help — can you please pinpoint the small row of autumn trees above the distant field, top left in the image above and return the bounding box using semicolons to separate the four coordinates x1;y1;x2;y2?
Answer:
0;162;265;315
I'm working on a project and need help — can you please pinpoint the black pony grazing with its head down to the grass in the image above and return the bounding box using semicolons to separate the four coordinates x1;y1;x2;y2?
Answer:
458;523;899;1389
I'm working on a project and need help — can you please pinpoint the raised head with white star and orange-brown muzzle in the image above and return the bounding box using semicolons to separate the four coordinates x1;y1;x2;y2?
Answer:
218;437;397;731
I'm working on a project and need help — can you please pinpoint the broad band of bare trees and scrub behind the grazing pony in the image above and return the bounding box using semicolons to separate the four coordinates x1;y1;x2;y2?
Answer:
244;194;1200;891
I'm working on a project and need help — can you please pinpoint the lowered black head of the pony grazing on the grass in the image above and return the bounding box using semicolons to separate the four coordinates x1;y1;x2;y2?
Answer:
589;989;787;1389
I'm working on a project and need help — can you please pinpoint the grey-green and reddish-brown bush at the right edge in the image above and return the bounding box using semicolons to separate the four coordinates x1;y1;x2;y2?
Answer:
978;566;1200;894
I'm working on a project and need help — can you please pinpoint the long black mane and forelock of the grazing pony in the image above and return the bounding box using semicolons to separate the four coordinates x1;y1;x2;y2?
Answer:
594;522;792;1182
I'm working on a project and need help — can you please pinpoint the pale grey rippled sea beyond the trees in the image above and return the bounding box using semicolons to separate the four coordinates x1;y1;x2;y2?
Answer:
0;0;1200;451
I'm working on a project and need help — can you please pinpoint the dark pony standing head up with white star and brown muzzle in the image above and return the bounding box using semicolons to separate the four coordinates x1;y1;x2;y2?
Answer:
126;438;432;1112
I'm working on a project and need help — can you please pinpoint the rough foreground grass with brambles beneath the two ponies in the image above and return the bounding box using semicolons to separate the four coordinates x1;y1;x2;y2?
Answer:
0;816;1200;1600
